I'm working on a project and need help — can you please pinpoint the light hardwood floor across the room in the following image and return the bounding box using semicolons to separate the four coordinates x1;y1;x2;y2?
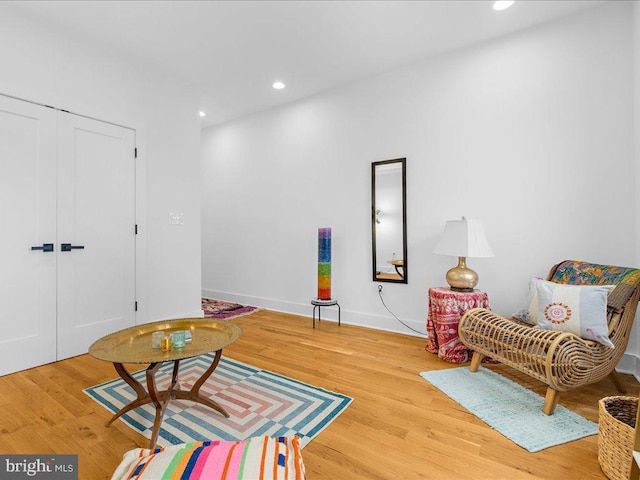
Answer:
0;311;639;480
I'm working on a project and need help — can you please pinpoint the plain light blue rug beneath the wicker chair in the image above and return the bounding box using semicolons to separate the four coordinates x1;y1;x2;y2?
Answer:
420;367;598;452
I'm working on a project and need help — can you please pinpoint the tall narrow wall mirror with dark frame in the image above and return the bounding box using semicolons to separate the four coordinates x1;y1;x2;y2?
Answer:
371;158;407;283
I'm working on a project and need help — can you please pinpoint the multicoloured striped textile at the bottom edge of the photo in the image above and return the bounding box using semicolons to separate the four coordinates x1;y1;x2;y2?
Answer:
111;436;306;480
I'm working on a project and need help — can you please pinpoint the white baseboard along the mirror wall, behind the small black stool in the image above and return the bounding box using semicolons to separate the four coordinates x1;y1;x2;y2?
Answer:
202;289;427;341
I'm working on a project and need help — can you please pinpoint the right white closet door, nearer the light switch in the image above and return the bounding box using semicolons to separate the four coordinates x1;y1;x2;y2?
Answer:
57;112;135;360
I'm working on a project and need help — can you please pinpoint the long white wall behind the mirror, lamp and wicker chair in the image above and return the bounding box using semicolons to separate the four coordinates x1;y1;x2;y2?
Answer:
202;2;638;344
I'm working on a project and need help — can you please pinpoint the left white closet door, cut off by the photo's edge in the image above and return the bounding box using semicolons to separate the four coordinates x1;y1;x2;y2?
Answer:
0;96;57;375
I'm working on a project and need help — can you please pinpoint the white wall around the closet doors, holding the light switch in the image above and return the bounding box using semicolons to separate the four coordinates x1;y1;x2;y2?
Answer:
0;2;201;323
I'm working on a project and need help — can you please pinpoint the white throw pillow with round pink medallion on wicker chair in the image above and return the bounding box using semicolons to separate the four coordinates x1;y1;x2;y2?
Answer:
534;280;614;348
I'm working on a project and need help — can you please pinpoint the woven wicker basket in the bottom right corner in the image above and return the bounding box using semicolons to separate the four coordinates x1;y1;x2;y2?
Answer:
598;396;638;480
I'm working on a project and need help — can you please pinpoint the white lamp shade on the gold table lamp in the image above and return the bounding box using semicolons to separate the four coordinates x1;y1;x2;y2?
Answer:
433;219;494;257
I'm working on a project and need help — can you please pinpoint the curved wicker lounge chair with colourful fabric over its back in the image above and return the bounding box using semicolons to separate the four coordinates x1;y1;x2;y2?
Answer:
459;260;640;415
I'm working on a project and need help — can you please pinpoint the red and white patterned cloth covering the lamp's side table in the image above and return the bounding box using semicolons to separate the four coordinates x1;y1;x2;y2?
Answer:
425;287;489;363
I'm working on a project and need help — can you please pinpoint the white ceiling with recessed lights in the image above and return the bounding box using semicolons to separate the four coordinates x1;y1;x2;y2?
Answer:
7;0;603;126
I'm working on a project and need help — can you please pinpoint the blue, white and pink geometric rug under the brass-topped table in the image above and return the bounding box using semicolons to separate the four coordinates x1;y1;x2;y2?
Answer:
84;354;353;447
